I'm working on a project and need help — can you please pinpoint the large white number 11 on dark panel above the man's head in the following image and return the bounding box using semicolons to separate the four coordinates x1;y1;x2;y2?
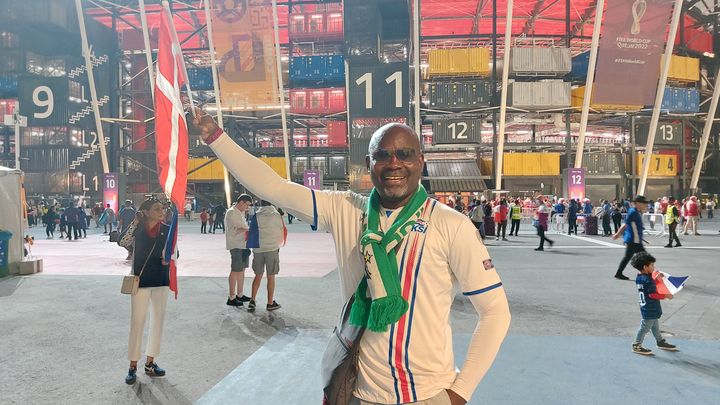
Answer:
349;62;409;118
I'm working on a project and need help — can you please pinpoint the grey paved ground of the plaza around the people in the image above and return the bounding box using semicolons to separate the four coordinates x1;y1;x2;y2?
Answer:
0;216;720;404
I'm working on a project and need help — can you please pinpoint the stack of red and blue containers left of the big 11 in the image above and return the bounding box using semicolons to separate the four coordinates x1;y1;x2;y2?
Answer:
288;0;348;185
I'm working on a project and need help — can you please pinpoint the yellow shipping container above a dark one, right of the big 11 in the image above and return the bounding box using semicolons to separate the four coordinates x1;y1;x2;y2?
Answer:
428;48;490;77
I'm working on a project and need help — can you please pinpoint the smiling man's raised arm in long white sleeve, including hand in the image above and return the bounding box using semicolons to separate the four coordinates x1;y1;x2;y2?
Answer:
194;109;314;224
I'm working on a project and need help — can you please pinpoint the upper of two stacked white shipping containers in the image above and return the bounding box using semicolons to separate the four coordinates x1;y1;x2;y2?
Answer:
510;47;571;76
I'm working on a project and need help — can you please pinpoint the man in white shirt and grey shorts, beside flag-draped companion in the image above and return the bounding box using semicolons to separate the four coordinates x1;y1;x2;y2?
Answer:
225;194;252;307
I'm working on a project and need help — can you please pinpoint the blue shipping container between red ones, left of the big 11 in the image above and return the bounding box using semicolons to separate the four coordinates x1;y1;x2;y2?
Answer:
290;55;345;86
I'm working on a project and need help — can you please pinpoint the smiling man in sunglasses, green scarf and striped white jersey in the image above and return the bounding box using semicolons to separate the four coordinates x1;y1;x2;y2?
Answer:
195;113;510;405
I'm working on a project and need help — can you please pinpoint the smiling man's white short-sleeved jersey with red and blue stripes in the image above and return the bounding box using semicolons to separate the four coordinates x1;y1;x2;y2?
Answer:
313;192;502;404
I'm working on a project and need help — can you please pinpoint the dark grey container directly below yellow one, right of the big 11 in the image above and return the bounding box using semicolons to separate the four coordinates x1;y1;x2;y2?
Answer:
428;80;495;110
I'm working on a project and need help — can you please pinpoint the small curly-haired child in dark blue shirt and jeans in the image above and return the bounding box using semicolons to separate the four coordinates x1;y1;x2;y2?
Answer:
630;252;677;356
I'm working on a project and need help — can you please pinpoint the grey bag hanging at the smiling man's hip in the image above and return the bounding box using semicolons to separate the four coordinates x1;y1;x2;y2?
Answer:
320;294;365;405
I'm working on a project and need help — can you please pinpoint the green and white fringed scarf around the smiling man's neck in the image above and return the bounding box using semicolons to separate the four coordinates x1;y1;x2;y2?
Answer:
350;185;427;332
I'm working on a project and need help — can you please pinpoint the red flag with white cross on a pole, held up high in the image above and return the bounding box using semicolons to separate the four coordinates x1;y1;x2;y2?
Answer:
155;3;188;214
